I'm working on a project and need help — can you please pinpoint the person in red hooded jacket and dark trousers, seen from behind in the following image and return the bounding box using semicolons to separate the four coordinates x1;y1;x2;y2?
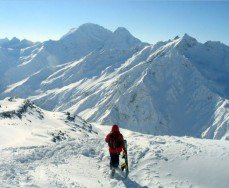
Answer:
105;125;126;170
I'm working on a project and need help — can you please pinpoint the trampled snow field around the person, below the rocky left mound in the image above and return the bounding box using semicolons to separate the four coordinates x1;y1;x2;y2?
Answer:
0;123;229;188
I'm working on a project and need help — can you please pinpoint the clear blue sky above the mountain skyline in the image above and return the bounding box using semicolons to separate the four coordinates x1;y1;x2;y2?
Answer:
0;0;229;45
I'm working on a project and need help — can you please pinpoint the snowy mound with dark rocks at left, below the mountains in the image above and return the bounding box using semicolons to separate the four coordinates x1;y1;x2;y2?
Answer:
0;98;97;148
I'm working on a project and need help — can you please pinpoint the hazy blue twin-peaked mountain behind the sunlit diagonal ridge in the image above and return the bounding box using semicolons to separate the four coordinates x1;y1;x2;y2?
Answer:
1;23;142;87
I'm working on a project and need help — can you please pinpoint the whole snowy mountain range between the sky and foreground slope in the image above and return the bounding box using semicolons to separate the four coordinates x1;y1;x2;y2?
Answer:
0;24;229;139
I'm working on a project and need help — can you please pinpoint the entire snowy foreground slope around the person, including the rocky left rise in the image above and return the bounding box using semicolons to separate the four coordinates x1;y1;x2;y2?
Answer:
0;98;229;188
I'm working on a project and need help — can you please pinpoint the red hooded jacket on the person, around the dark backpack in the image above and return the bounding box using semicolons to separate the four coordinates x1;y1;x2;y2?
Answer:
105;125;125;154
